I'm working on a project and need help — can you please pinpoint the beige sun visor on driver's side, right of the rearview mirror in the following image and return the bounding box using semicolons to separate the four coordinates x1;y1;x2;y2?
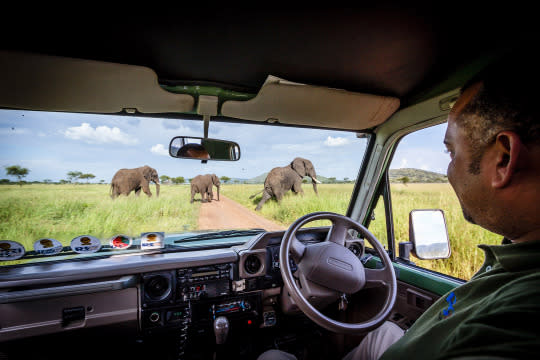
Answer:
221;76;399;130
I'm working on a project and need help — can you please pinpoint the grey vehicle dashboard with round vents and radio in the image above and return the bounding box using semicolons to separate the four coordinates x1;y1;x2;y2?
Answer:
0;227;364;356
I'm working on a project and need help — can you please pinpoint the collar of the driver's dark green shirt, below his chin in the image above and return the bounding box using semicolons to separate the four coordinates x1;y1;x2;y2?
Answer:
478;238;540;271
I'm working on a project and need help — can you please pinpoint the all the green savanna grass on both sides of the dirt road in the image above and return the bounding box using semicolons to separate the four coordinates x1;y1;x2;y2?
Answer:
0;184;501;279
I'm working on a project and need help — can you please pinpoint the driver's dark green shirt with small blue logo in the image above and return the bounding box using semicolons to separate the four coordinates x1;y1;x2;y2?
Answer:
381;240;540;360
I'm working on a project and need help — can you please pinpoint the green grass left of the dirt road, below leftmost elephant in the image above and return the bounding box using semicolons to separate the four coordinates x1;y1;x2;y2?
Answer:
0;184;200;250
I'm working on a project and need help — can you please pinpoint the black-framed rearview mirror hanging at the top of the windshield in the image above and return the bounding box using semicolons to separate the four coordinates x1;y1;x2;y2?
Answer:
169;136;240;161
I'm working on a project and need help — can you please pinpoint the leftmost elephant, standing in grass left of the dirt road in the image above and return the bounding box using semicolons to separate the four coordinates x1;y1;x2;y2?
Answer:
110;165;159;199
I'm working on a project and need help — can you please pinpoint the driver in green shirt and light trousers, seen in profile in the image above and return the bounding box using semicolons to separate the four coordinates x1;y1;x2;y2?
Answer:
259;54;540;360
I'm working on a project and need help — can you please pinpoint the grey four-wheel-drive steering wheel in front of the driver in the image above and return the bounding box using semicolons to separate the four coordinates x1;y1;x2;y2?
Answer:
279;212;397;334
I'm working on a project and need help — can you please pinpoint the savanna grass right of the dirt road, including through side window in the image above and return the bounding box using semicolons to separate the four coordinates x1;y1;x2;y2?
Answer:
222;183;501;280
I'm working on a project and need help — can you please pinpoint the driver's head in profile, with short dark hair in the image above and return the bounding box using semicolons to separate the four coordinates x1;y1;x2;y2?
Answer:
444;58;540;240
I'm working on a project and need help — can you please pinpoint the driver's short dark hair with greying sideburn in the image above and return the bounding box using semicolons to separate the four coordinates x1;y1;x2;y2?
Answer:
456;52;540;174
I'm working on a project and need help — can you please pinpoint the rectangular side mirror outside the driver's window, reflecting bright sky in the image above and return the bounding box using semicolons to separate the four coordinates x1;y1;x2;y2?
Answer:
409;209;450;260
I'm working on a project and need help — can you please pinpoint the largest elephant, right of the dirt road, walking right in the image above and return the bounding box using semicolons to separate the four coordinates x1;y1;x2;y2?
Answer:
249;157;321;211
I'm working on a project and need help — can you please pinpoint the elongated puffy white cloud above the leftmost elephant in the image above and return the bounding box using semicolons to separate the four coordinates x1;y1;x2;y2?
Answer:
62;123;139;145
